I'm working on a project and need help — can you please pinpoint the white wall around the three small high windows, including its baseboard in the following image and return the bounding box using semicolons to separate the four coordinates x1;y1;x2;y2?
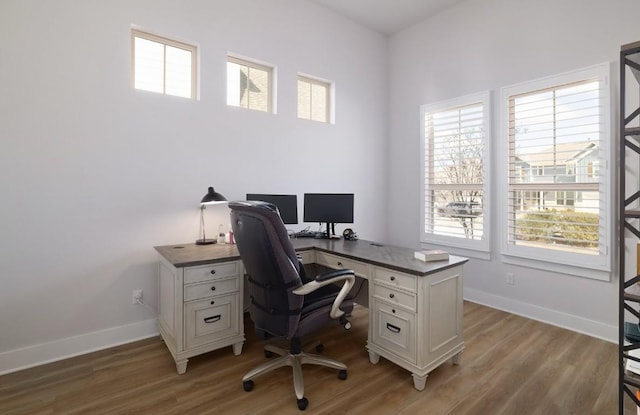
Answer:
0;0;388;373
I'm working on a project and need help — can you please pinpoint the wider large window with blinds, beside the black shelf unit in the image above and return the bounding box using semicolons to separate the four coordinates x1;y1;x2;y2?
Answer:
502;64;612;278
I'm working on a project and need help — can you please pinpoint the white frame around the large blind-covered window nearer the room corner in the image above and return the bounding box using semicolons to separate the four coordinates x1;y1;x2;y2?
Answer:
419;91;492;255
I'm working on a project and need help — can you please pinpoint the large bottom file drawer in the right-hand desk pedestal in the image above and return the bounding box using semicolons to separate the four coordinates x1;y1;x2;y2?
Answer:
369;299;417;364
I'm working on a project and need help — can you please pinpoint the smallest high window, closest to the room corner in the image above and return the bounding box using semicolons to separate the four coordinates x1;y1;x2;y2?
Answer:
298;75;331;123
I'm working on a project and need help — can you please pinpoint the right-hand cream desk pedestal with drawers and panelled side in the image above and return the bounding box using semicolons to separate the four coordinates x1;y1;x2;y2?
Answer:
367;267;464;390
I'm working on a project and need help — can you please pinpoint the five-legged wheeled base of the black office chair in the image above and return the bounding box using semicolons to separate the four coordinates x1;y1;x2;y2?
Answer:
242;344;347;409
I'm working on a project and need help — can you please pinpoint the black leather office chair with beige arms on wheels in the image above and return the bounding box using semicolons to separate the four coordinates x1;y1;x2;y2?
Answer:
229;201;355;410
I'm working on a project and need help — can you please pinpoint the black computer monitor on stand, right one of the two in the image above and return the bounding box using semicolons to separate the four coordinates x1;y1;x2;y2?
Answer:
304;193;353;238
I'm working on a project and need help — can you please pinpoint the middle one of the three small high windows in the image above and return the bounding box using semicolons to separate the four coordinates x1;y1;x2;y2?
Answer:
227;56;275;112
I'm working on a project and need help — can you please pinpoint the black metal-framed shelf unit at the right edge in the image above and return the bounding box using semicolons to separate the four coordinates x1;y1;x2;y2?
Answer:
618;42;640;415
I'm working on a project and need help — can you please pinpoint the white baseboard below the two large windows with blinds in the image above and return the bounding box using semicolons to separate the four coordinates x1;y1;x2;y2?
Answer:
464;288;618;343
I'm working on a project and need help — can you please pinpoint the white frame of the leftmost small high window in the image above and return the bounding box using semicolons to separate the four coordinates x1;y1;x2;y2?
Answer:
131;27;200;100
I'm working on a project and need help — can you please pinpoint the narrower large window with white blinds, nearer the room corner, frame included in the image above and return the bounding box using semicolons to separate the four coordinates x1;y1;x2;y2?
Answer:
421;92;490;252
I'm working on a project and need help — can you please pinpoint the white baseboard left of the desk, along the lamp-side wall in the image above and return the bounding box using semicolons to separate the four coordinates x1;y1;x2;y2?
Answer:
0;318;158;375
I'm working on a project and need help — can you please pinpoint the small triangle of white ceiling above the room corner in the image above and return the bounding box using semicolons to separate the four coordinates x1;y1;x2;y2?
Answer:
311;0;463;35
